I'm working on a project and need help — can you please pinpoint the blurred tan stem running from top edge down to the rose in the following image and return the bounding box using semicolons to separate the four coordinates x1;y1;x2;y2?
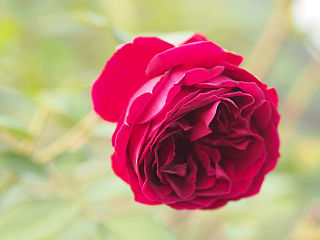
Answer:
245;0;293;79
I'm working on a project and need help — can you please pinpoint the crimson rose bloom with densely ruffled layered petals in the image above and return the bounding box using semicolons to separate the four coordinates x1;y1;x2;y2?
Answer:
92;34;279;209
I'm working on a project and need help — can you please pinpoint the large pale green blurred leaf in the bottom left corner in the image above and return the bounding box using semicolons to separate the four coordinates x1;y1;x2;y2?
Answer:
0;199;80;240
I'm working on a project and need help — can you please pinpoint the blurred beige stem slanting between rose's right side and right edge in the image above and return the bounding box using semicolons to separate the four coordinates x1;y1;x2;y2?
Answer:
280;60;320;142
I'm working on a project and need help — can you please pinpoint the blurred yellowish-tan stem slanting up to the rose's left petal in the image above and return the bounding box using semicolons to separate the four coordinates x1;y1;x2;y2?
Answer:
34;112;99;163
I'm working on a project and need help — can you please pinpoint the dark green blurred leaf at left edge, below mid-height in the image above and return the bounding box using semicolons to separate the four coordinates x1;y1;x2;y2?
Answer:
0;152;46;176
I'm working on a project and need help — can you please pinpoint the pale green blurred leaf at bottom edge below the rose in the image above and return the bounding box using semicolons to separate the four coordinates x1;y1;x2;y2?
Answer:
106;214;177;240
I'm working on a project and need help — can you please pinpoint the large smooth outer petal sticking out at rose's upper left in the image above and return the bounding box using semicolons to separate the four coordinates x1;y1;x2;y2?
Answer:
92;37;173;122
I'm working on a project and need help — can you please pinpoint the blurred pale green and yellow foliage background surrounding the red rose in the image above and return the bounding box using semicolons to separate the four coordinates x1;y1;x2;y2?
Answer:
0;0;320;240
